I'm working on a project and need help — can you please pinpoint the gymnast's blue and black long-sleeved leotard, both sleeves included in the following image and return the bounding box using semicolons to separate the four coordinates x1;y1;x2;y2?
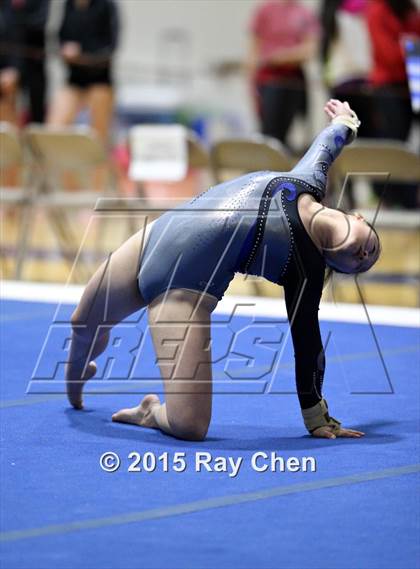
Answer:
138;124;352;409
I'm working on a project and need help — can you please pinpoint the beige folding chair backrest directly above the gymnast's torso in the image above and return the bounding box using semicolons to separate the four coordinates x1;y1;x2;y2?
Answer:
210;135;294;183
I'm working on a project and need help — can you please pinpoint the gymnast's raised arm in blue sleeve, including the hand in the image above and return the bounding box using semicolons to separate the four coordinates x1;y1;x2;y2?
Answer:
291;99;360;197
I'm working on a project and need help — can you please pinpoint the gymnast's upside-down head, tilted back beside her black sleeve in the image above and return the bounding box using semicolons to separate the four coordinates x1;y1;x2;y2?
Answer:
323;210;381;274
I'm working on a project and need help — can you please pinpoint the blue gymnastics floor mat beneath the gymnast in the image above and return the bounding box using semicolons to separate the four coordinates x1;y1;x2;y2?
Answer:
0;300;420;569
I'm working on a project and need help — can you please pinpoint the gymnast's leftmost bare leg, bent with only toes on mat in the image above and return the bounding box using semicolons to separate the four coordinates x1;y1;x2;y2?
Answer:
66;223;152;409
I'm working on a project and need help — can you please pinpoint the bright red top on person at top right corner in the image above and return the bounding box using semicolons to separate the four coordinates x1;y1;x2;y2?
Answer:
366;0;420;85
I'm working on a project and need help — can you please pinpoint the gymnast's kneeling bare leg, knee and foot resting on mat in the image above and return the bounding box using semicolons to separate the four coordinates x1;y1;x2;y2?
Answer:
112;289;217;440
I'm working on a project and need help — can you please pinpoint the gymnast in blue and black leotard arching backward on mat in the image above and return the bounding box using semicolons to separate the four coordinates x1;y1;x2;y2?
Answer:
66;99;380;440
